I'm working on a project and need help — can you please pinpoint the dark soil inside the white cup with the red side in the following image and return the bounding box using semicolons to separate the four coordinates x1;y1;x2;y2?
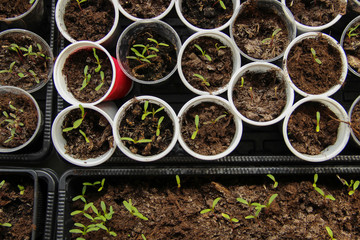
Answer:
62;48;113;103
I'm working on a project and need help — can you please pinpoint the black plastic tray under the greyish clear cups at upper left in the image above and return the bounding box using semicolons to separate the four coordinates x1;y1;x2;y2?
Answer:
0;0;56;164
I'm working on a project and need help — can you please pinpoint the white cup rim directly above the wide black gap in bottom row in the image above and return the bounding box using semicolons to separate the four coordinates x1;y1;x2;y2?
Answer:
228;62;295;127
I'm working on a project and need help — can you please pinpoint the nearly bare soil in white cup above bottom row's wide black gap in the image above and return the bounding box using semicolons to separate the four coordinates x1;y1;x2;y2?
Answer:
233;70;286;122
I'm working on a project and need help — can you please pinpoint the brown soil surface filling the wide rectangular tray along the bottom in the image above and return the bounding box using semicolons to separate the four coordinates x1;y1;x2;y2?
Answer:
69;175;360;240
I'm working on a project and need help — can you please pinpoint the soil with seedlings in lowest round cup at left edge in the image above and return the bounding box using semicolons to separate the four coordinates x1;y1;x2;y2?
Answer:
0;92;39;148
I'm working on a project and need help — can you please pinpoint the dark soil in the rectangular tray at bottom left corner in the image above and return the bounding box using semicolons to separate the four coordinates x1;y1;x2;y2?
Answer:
0;176;36;240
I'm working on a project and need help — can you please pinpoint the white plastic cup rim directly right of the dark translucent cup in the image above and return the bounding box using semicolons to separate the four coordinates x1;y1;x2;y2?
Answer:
177;31;241;95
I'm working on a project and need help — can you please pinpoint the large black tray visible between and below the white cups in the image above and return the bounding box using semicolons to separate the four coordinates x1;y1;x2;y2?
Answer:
57;8;360;166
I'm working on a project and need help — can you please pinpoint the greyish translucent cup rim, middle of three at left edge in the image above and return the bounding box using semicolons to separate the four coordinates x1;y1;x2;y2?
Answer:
0;29;54;93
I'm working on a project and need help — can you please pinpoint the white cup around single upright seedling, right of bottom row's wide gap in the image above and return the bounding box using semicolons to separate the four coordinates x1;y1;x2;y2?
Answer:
283;96;350;162
